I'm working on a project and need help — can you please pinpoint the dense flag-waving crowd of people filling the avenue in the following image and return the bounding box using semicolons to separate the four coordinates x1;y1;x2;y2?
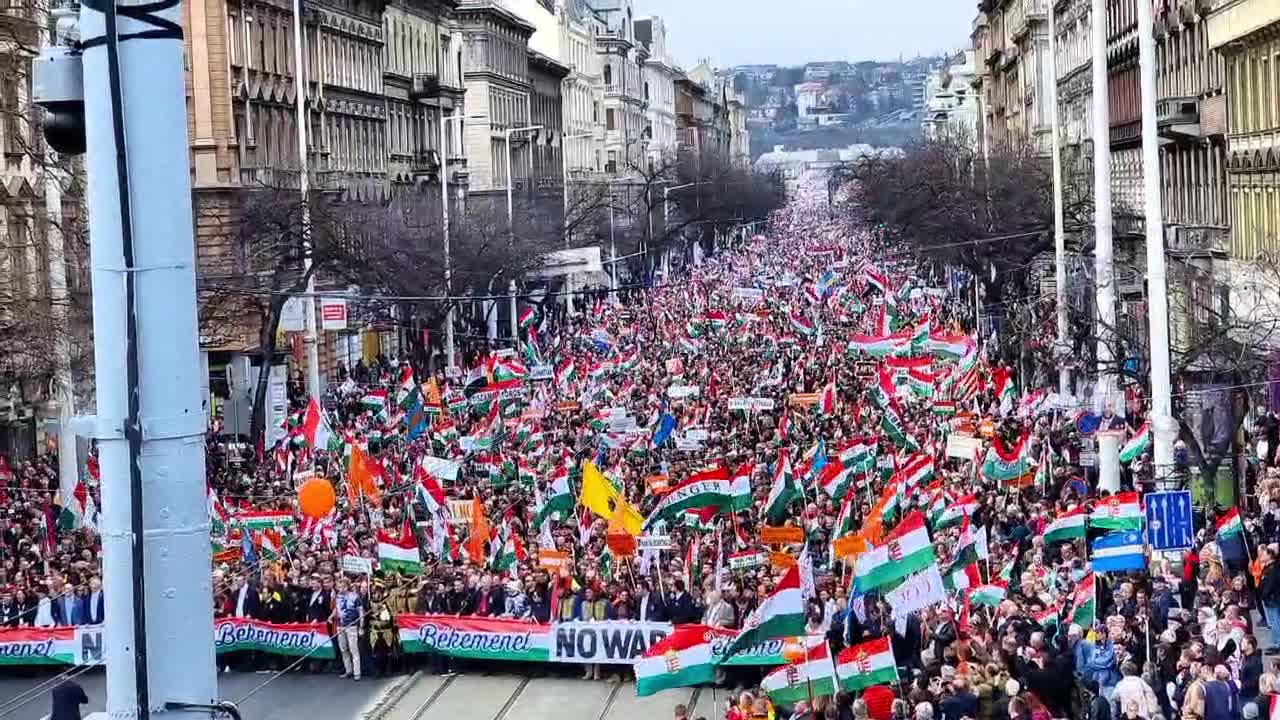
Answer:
0;178;1280;720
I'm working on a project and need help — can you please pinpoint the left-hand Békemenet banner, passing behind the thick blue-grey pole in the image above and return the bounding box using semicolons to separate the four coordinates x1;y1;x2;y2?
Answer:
0;618;335;665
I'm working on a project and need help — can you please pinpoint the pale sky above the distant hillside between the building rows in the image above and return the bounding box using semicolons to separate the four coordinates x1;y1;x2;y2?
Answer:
635;0;978;68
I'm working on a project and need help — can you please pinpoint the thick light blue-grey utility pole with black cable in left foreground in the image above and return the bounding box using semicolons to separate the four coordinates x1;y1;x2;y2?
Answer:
81;0;216;720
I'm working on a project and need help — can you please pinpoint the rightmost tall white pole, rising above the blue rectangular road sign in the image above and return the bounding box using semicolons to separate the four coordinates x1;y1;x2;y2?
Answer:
1138;3;1178;479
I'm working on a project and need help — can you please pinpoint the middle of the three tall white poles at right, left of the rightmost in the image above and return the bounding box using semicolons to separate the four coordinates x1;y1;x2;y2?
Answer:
1091;0;1121;492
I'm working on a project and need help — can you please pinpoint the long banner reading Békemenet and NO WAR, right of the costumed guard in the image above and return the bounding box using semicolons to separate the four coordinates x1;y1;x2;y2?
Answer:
396;615;785;665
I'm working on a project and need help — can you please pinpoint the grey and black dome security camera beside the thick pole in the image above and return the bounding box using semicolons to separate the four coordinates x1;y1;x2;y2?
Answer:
31;45;84;155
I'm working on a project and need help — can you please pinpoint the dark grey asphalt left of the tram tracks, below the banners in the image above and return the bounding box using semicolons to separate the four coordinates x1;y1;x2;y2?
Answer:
0;667;396;720
